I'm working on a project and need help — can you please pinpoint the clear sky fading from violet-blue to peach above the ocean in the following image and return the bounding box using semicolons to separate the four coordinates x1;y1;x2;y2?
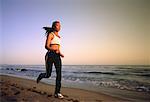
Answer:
0;0;150;65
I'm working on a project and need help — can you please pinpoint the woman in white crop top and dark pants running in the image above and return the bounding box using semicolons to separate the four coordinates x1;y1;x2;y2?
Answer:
37;21;64;98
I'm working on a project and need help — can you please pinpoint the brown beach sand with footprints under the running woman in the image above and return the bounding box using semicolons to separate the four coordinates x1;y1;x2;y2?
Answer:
0;75;130;102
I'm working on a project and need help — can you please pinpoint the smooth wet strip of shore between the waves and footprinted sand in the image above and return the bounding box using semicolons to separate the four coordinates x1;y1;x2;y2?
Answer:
0;73;150;102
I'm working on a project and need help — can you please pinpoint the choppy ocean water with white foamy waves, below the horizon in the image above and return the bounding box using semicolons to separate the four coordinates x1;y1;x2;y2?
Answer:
0;65;150;101
